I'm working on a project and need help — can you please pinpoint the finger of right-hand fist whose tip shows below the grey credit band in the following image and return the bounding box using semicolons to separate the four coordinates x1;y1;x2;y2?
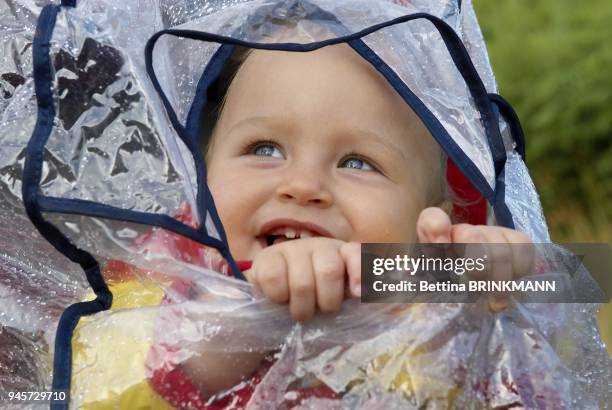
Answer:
478;226;513;312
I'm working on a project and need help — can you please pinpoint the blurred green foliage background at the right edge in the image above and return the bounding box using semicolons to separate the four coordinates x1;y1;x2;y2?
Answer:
473;0;612;354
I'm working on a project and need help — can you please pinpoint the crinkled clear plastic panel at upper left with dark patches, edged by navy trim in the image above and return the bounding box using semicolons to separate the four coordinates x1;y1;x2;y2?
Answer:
41;9;202;223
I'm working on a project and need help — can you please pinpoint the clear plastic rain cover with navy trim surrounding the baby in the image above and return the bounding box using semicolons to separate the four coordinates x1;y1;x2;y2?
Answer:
0;0;612;409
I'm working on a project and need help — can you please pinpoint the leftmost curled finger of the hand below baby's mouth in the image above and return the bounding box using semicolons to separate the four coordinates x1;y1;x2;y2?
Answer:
247;248;289;303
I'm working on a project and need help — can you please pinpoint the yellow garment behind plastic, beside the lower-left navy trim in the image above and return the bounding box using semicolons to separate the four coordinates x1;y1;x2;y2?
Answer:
71;280;173;410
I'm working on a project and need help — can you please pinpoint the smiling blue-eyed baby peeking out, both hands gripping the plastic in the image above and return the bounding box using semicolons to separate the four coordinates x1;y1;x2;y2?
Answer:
169;45;533;396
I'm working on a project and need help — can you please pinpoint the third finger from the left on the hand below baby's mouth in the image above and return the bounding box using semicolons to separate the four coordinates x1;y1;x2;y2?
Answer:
312;246;346;313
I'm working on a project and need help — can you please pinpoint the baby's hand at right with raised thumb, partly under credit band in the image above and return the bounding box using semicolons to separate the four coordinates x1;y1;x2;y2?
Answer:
417;208;535;312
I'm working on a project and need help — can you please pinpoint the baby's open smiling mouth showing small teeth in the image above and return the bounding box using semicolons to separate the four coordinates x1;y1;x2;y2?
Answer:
257;219;333;248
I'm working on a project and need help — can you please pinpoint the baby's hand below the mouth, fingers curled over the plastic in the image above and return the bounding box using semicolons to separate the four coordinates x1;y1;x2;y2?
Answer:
245;237;361;321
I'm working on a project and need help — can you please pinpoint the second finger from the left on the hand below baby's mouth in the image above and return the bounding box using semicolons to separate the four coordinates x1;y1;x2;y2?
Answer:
283;247;316;321
